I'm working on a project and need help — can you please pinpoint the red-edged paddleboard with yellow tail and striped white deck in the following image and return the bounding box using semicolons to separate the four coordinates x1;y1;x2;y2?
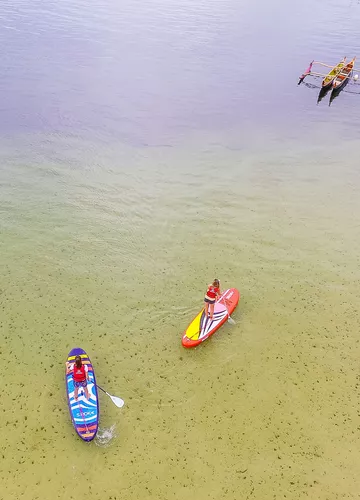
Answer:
182;288;240;347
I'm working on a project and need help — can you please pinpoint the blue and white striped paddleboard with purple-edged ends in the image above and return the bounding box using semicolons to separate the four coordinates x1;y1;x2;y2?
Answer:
65;347;100;441
